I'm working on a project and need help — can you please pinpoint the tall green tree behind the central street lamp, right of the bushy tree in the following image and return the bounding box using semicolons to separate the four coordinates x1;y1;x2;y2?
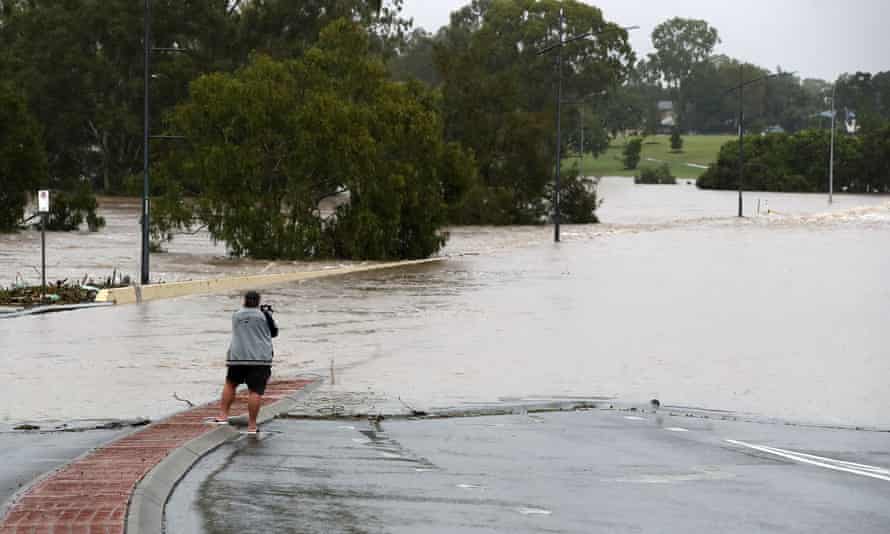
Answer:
435;0;633;224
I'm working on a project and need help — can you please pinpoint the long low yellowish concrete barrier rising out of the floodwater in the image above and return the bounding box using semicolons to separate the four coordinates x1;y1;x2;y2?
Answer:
96;258;445;304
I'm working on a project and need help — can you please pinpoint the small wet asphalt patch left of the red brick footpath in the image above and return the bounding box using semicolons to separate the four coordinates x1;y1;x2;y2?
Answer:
0;428;126;513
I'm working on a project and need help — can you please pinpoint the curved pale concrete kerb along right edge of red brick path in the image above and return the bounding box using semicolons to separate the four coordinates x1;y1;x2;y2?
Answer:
125;380;322;534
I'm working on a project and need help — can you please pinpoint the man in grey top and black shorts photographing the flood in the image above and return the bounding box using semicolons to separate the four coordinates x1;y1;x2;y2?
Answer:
214;291;278;435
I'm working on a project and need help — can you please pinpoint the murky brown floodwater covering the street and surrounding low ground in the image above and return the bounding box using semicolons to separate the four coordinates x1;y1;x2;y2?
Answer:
0;179;890;428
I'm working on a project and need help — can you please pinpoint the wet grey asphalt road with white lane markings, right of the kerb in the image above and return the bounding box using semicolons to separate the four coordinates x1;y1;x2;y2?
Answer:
166;410;890;534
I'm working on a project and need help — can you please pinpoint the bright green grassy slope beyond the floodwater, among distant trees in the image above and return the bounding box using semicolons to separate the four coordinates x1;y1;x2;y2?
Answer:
563;135;738;178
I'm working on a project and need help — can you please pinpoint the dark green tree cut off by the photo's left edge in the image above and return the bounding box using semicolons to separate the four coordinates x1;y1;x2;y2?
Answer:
0;82;47;232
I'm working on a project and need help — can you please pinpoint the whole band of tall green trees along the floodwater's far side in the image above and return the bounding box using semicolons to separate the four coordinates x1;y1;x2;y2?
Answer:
0;0;890;259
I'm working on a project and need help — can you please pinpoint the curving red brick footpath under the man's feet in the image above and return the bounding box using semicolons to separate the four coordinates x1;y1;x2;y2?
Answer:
0;380;311;534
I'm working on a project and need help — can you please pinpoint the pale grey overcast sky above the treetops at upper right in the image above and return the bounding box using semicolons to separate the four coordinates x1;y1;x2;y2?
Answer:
405;0;890;81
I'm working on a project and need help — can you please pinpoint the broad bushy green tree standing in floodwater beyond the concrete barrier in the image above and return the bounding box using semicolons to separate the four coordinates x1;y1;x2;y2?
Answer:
156;19;473;259
